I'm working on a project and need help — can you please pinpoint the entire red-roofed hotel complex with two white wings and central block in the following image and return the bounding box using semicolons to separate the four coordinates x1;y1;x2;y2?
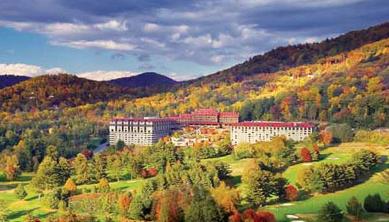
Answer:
109;109;315;146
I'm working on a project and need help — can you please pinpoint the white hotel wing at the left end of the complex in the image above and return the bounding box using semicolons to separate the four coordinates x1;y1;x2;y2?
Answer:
109;118;175;146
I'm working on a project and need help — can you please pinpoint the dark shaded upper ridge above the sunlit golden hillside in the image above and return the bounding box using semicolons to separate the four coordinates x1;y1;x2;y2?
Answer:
187;22;389;85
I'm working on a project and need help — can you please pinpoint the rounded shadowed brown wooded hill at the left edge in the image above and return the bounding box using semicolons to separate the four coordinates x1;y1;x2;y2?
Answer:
0;74;141;112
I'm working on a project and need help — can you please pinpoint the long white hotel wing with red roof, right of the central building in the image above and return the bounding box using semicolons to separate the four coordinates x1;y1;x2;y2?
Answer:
230;121;315;145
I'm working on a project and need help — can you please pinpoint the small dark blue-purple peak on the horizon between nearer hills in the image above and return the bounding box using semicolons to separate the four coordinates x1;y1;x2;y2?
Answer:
108;72;178;88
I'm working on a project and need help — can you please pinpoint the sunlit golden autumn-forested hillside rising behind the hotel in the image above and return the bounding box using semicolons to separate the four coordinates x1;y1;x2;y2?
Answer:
101;38;389;128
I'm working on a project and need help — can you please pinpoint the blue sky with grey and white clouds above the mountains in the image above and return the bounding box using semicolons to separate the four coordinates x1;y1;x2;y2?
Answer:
0;0;389;80
